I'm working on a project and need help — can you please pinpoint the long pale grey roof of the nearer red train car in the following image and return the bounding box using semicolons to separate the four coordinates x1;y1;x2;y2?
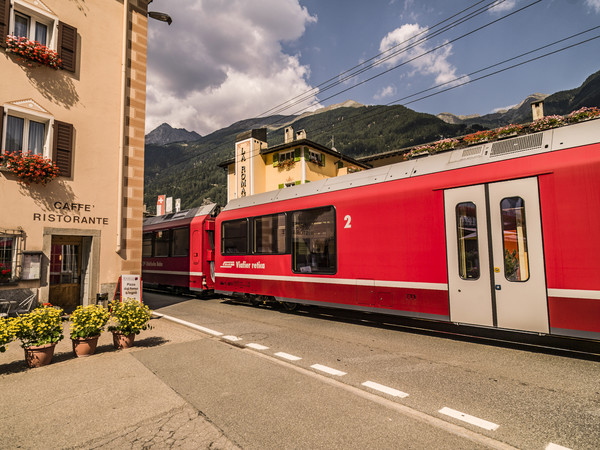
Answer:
223;119;600;211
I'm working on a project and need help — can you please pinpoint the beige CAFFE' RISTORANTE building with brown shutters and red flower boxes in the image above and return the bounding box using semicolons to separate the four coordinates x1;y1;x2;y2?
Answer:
0;0;151;309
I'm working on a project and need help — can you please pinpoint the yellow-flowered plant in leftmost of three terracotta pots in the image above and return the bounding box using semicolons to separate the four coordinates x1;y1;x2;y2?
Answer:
10;306;64;367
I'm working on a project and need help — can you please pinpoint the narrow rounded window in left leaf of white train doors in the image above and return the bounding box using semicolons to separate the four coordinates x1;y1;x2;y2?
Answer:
456;202;479;280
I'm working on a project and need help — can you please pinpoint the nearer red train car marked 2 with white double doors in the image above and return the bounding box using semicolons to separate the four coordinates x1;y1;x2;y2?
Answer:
215;120;600;340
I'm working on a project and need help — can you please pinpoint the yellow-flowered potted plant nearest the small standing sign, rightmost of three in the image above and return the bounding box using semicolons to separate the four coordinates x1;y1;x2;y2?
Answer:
108;299;152;349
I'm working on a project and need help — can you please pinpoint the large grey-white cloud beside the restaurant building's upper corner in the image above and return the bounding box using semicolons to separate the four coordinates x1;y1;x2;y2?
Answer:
146;0;317;135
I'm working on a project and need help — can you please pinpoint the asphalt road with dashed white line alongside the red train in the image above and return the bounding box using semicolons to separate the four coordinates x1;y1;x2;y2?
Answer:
136;292;600;449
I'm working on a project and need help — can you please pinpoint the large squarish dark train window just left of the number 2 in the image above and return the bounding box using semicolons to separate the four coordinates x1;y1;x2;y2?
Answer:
292;206;336;274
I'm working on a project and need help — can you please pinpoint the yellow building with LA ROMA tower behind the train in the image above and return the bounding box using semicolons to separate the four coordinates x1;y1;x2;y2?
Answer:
219;127;370;201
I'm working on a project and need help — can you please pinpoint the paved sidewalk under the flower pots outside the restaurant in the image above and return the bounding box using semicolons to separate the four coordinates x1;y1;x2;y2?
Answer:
0;319;238;449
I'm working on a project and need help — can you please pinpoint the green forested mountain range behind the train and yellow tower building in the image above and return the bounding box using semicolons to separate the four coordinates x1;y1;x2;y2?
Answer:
144;72;600;210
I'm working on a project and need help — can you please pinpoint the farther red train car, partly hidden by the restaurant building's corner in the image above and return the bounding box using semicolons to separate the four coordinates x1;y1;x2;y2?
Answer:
142;204;216;294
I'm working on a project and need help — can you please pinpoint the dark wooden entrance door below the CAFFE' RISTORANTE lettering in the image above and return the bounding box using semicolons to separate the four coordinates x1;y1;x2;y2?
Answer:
48;236;83;311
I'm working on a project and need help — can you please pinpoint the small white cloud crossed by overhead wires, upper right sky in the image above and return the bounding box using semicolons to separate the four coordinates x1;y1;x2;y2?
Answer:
379;24;468;88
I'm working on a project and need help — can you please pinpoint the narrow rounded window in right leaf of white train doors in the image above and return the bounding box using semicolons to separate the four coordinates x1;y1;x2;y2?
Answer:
500;197;529;281
